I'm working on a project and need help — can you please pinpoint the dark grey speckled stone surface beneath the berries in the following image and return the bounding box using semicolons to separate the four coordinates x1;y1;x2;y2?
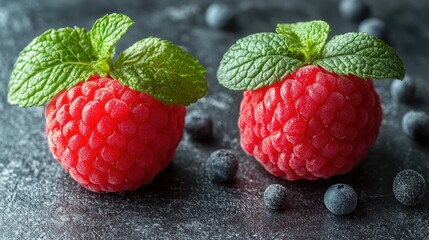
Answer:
0;0;429;239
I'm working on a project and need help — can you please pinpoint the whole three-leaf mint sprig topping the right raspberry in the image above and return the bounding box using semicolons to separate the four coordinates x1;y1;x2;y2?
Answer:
217;21;405;90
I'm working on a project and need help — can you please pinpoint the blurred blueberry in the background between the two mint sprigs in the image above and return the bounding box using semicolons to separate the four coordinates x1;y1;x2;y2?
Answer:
205;3;235;29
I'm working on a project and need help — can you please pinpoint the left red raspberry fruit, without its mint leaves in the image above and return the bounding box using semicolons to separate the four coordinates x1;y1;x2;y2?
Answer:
45;76;186;192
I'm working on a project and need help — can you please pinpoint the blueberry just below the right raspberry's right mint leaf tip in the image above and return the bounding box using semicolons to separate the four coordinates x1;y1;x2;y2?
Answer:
390;75;416;102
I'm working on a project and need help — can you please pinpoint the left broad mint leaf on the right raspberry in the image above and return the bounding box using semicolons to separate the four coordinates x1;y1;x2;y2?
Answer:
217;33;304;90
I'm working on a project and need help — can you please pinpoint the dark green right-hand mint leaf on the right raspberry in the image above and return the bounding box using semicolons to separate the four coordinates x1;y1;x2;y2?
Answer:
314;33;405;79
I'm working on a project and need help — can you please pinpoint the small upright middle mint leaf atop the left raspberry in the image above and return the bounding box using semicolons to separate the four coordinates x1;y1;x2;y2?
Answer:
90;13;134;68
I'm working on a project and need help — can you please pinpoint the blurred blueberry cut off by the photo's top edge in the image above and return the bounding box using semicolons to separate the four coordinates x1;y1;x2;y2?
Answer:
338;0;370;22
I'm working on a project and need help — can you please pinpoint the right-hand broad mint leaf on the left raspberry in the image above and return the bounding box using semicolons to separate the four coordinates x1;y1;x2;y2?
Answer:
110;37;207;105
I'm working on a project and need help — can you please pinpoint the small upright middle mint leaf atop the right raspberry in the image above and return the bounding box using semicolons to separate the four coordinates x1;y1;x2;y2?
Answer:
276;21;330;64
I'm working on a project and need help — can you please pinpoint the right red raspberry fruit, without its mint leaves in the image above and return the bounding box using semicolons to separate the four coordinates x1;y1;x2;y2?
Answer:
238;66;382;180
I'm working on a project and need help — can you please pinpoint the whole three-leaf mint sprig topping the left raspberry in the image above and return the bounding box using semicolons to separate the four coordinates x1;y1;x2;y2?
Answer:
8;14;207;107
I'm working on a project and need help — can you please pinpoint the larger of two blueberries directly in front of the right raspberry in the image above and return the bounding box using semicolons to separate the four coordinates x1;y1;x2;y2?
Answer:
324;183;357;215
